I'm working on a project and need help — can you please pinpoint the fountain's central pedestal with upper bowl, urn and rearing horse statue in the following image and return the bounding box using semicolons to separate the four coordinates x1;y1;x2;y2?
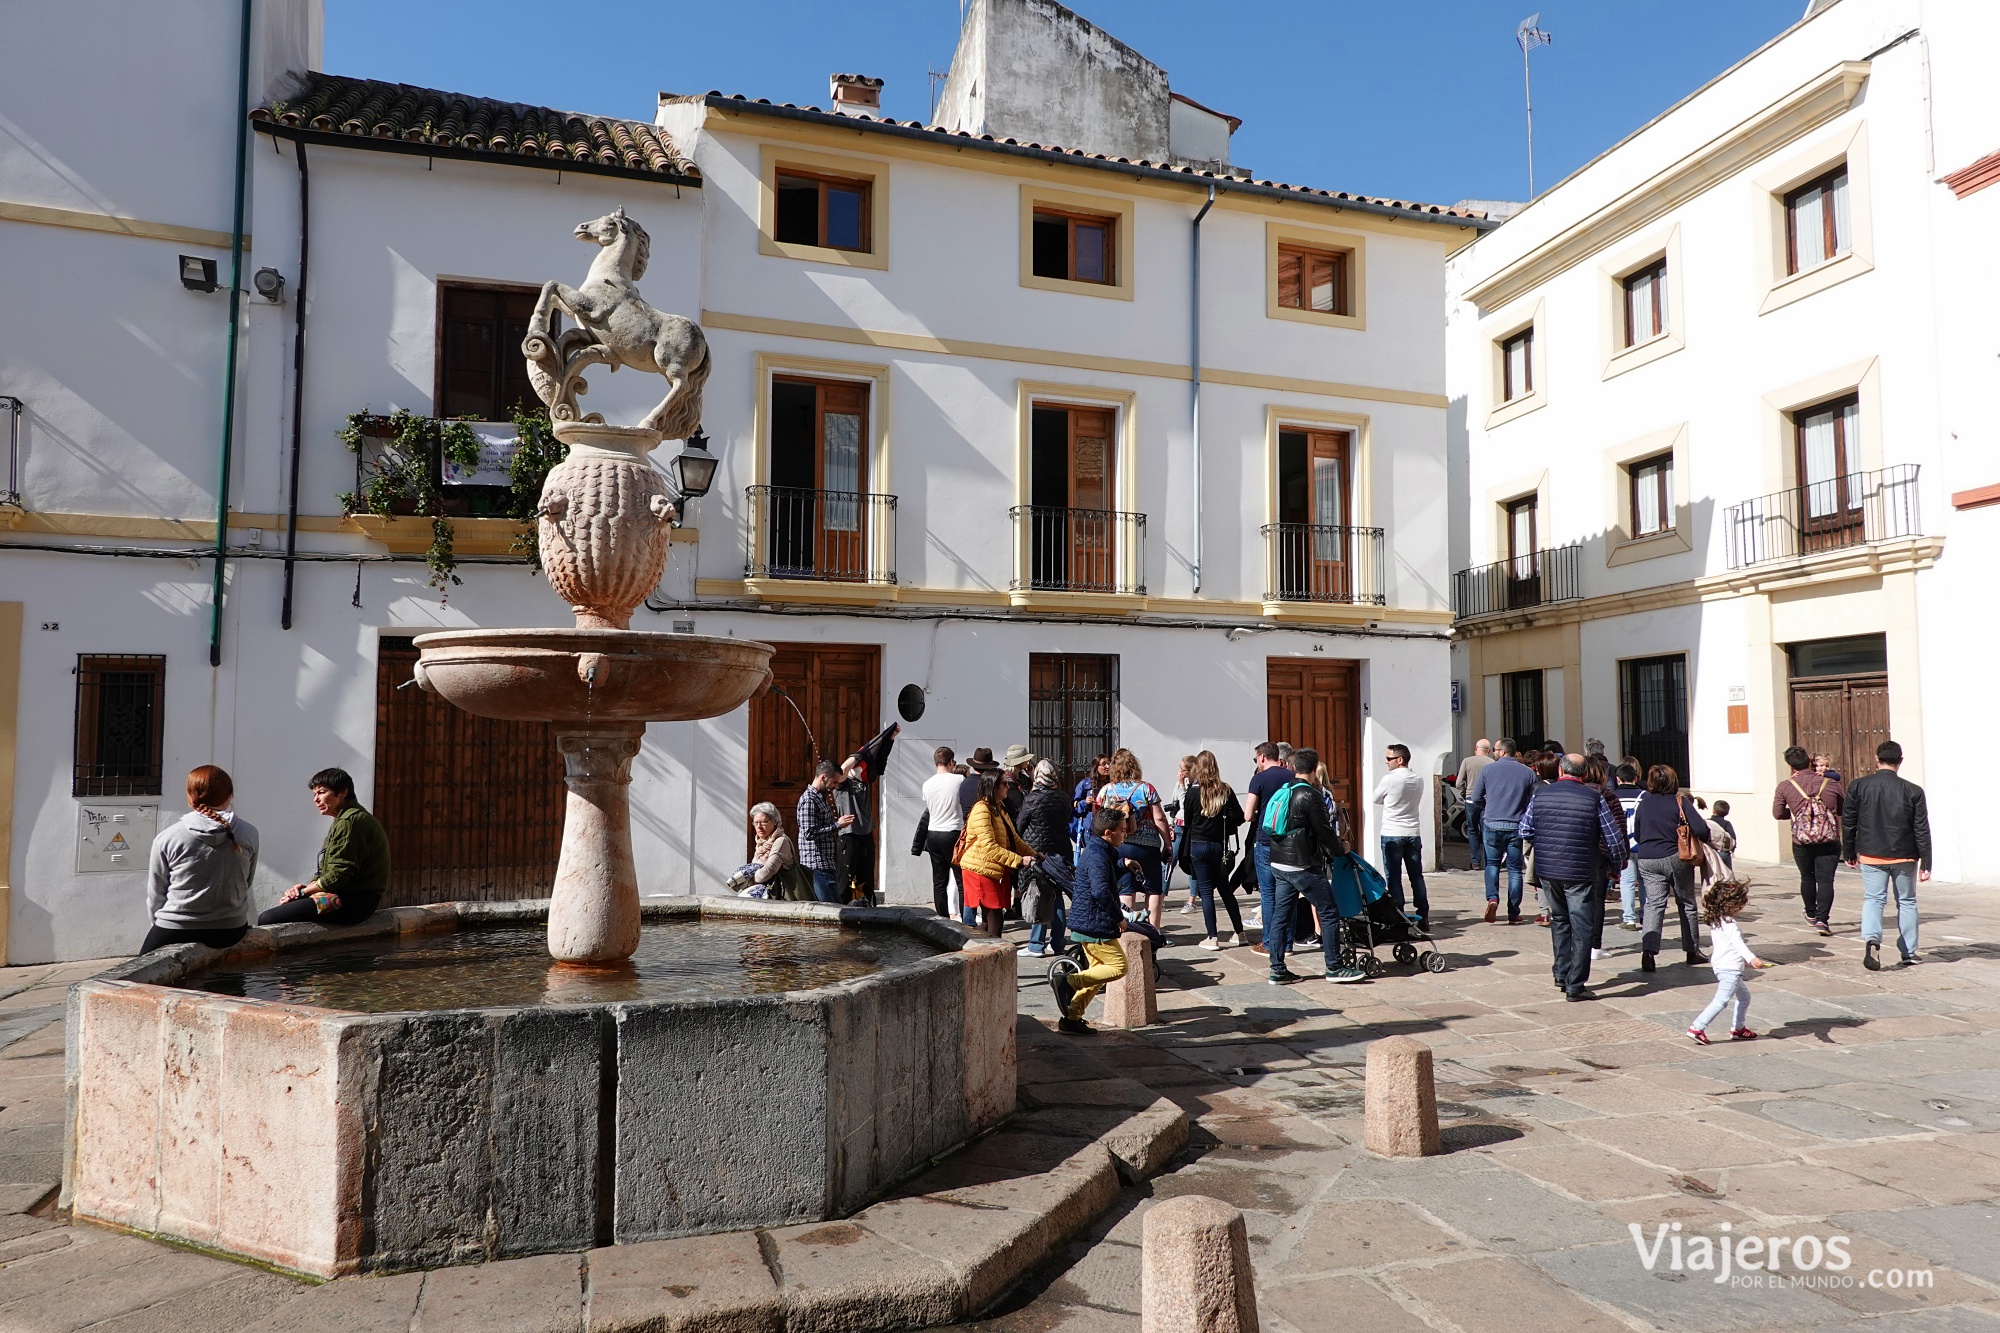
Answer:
416;208;772;965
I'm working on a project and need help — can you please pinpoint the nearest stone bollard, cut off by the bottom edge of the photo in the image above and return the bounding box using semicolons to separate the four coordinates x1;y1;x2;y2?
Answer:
1140;1195;1258;1333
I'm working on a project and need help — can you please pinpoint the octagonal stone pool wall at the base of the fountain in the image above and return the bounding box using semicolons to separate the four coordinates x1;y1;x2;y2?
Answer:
62;897;1016;1277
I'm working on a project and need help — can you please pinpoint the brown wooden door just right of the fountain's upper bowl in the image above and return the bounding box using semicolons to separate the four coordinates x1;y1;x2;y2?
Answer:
744;642;882;845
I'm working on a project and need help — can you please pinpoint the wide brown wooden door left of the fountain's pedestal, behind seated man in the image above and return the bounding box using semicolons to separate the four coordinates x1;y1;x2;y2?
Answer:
374;638;564;907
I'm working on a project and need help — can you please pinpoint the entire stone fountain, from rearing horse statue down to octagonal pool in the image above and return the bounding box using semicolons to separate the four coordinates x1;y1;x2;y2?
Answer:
62;210;1016;1280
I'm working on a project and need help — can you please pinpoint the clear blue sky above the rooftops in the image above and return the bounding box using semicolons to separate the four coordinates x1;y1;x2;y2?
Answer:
326;0;1806;204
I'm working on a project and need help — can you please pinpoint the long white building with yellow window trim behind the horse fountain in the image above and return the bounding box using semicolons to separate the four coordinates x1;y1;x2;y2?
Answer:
0;0;1482;963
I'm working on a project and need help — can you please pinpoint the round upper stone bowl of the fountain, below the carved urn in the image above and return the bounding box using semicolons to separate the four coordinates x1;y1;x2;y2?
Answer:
416;628;772;727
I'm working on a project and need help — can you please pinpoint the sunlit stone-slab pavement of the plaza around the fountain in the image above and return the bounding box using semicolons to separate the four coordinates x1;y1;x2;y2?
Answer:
0;869;2000;1333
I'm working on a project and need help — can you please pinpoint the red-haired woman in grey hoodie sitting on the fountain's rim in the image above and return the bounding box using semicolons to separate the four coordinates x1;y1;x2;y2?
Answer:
140;765;256;953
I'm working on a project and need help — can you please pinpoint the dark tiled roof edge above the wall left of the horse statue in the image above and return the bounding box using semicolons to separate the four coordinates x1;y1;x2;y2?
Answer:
250;70;698;178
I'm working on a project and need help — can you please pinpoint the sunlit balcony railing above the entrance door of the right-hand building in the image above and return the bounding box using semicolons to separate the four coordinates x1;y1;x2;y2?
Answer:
1722;462;1924;568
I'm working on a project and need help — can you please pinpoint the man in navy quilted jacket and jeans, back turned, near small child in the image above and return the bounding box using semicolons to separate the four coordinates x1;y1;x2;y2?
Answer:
1520;755;1626;1001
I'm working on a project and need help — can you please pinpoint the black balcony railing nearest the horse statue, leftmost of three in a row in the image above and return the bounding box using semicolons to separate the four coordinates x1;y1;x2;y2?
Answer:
744;486;896;584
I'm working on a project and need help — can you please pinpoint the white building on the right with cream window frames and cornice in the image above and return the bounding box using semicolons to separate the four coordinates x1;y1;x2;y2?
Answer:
1450;0;2000;883
